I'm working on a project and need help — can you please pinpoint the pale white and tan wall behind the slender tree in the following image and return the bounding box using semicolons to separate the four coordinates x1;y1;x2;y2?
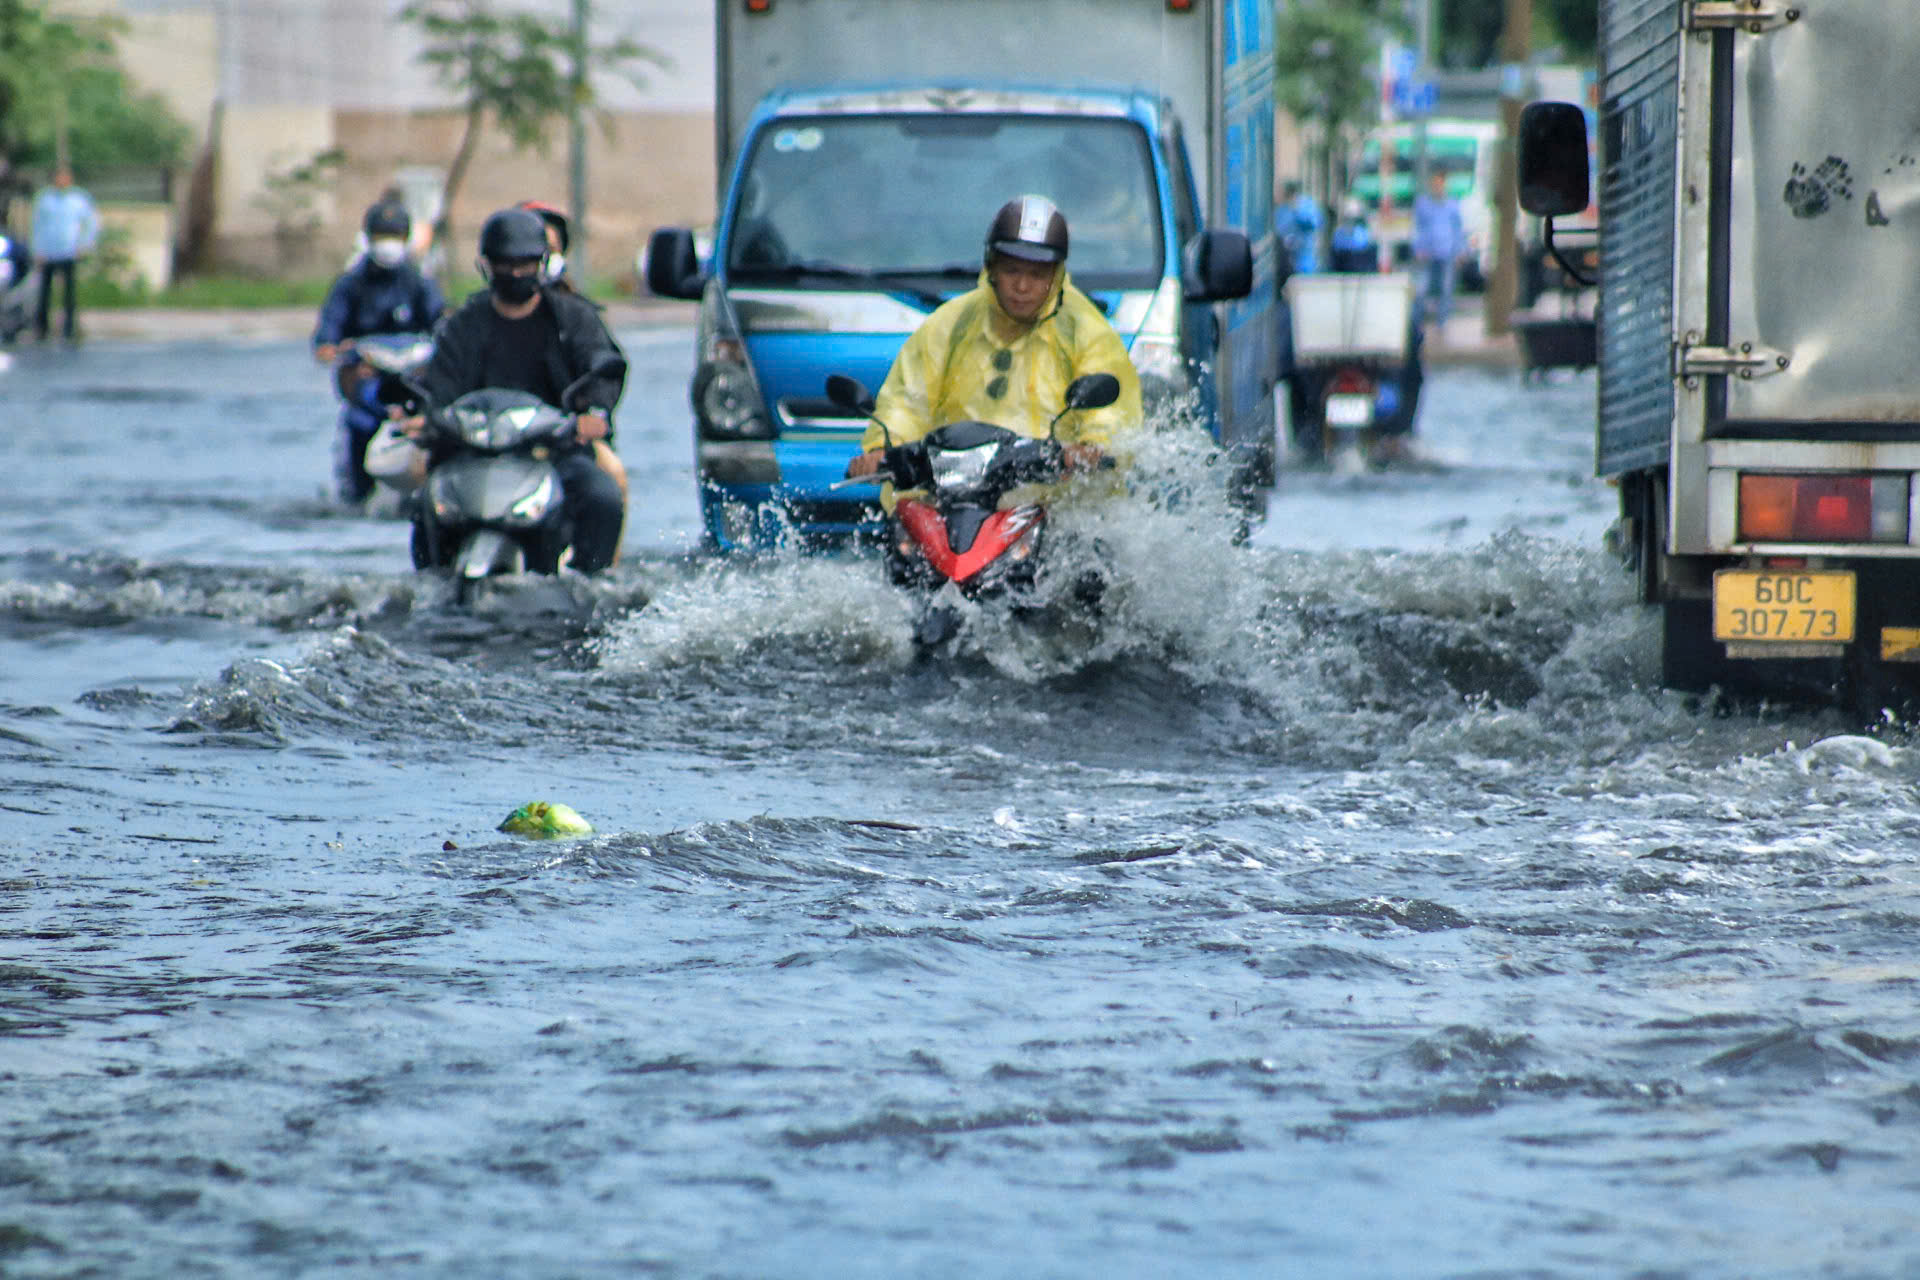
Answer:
50;0;714;273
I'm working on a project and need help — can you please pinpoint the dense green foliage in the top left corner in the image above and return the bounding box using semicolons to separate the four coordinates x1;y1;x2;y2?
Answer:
0;0;190;175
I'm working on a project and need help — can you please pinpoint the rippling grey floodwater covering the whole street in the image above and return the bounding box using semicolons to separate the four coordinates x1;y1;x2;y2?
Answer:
0;330;1920;1280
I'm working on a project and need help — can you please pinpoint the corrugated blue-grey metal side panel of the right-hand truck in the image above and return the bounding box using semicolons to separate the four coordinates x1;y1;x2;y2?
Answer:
1596;0;1682;476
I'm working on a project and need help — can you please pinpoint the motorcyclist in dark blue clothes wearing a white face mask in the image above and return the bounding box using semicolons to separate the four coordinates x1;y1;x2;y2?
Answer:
313;201;445;503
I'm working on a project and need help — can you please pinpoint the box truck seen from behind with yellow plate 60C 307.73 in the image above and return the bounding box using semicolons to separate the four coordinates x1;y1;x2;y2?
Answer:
1519;0;1920;714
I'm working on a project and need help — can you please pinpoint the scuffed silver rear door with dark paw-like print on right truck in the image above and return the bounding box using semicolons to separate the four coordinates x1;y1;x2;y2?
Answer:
1712;0;1920;441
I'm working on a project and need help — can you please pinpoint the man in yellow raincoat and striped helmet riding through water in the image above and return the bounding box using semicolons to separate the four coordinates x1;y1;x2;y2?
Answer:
847;196;1140;491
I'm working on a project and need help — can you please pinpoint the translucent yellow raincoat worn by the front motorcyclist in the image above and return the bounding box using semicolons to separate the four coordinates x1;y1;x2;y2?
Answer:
860;267;1140;466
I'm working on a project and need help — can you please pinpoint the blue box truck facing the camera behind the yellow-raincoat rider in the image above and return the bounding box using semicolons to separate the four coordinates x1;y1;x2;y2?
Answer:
645;0;1284;549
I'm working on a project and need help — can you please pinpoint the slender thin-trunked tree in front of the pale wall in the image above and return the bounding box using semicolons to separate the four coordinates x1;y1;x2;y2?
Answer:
397;0;666;255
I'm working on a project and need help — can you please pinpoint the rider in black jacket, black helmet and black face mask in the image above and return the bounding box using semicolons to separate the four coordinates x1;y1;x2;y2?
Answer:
413;209;626;574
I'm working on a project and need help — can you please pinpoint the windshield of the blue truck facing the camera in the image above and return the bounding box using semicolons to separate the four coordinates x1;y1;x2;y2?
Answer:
726;113;1164;290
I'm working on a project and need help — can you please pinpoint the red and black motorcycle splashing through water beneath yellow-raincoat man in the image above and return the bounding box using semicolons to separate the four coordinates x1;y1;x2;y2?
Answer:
828;374;1119;649
